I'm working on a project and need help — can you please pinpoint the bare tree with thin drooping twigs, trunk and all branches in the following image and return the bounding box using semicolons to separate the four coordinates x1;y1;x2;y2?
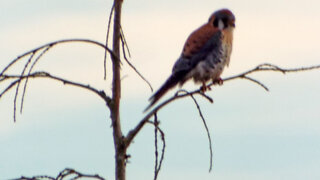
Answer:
0;0;320;180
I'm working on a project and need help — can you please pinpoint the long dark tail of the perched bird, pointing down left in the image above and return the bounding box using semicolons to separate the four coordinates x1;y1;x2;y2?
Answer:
144;73;185;112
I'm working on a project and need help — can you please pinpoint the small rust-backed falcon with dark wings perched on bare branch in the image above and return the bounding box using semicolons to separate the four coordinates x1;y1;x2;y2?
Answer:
146;9;235;110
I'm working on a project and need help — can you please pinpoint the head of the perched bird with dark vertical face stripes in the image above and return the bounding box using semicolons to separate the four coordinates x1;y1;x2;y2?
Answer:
209;9;236;30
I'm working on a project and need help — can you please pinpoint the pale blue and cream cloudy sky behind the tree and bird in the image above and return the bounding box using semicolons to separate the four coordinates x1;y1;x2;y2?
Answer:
0;0;320;180
